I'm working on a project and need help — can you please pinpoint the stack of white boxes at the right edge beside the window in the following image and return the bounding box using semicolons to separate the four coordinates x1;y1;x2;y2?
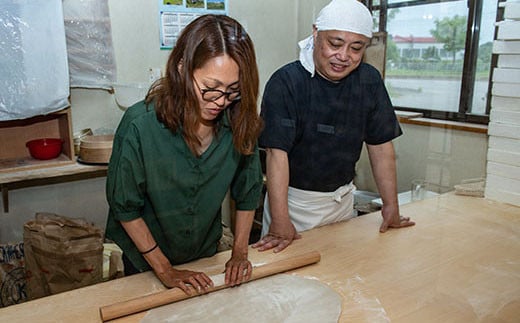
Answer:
485;0;520;206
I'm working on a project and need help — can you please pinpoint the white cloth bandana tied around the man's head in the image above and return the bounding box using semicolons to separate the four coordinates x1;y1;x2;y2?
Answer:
298;0;373;76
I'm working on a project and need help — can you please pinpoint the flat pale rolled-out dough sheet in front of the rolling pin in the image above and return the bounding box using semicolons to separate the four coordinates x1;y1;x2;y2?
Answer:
141;274;341;323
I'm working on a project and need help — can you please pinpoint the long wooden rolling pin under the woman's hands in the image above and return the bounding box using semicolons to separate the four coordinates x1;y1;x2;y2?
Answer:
99;251;320;322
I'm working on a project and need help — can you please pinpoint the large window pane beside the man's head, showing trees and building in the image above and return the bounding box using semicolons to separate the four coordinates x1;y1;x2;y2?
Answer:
385;0;468;112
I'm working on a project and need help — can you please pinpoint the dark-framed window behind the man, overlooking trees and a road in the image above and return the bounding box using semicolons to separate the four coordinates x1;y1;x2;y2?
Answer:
368;0;503;123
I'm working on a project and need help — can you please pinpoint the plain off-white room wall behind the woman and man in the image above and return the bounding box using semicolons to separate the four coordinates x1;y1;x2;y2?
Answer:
0;0;487;243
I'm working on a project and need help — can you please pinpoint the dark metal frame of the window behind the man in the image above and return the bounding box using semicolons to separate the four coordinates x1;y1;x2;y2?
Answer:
365;0;506;124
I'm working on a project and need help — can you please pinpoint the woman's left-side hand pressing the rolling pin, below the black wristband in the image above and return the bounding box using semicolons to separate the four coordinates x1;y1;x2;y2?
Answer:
155;267;213;296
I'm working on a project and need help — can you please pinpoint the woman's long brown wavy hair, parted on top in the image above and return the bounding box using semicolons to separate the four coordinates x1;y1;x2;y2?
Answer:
145;14;262;155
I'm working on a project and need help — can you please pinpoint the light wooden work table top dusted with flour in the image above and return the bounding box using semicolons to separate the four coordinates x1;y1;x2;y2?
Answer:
0;193;520;323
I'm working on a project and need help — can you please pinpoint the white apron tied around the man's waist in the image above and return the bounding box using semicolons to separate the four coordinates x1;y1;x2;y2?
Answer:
262;182;356;237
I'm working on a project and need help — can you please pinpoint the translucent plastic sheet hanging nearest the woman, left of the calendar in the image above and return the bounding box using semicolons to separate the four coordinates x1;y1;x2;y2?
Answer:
63;0;116;89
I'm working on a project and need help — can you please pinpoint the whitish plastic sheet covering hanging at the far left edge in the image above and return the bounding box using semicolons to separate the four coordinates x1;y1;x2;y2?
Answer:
0;0;69;121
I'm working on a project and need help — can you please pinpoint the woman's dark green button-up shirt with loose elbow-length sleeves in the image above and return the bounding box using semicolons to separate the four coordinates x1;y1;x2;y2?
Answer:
106;102;262;271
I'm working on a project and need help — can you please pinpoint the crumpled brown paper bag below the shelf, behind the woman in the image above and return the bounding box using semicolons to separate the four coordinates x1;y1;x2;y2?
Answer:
24;213;103;300
